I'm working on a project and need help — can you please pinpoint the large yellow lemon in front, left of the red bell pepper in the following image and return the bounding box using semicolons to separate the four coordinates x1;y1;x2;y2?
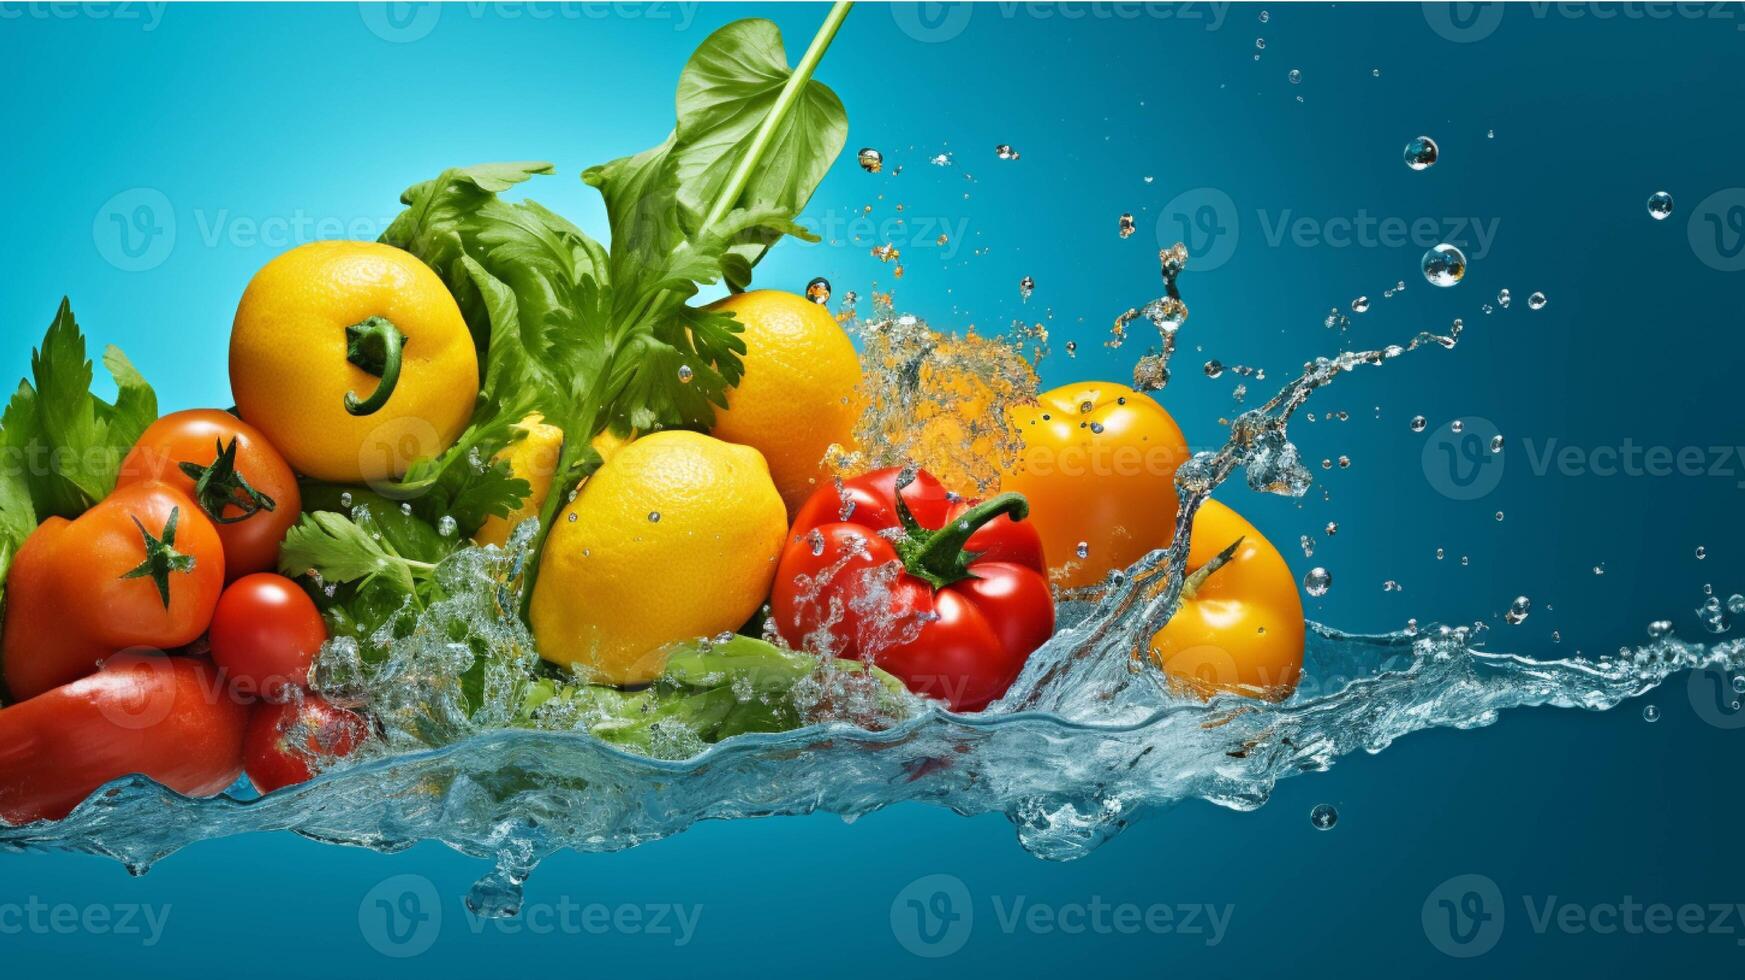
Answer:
529;431;787;684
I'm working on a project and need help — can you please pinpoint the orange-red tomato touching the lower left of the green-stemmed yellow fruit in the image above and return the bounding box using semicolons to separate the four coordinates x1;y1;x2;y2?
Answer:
117;408;304;579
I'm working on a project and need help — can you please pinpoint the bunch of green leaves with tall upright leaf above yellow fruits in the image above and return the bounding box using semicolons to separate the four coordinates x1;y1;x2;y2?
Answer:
382;21;848;551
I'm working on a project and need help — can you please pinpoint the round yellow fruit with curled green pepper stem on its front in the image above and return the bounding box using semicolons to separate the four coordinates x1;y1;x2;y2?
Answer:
230;241;478;483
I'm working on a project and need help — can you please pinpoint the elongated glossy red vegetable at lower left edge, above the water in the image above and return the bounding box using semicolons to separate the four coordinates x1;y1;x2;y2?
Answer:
0;652;248;823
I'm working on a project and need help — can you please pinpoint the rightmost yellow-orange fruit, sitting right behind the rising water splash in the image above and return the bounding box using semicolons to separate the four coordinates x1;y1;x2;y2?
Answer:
1150;500;1305;701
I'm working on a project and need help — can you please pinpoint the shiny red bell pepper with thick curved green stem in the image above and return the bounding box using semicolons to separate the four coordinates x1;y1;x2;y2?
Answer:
770;469;1054;711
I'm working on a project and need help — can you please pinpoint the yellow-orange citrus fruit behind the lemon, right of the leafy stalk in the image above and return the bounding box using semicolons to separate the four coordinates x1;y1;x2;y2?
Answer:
710;289;860;514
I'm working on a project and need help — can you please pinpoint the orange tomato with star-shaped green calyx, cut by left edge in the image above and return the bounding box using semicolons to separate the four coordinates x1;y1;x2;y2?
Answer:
0;483;223;701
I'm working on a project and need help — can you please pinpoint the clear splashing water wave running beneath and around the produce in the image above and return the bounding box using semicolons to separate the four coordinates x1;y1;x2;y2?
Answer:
0;246;1745;915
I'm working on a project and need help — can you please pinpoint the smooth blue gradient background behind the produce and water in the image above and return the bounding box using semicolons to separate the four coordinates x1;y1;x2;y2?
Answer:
0;3;1745;978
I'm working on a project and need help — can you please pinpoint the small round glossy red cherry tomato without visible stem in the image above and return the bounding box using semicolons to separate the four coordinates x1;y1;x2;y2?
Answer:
211;572;326;701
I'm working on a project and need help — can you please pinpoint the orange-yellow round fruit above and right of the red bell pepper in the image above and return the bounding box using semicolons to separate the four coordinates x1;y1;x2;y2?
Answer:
1000;382;1188;588
